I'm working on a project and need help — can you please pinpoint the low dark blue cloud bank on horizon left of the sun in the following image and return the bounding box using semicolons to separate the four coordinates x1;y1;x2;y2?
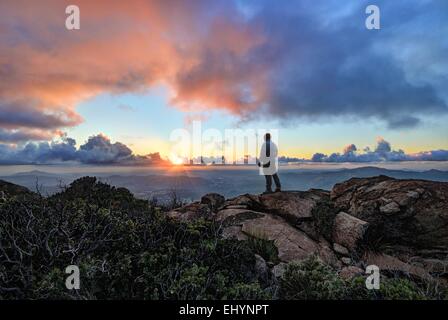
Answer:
0;134;167;165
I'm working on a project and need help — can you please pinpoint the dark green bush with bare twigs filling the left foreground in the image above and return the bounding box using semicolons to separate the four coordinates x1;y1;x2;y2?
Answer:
0;177;271;299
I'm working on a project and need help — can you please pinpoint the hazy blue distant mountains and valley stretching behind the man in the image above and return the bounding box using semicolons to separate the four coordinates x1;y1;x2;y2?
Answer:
0;166;448;201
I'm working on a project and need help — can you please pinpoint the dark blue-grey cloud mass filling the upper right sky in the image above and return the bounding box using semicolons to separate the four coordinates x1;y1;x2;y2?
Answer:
248;1;448;129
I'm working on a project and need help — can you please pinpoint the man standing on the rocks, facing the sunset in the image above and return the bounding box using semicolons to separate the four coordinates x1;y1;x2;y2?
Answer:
257;133;281;193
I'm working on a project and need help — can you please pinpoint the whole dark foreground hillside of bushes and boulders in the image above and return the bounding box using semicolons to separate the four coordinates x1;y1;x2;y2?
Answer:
0;176;448;299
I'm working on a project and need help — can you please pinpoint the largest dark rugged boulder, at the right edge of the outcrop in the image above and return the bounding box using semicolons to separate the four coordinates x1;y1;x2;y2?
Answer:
331;176;448;251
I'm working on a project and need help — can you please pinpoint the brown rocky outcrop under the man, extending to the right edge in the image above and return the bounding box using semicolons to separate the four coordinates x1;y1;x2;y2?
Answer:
168;176;448;284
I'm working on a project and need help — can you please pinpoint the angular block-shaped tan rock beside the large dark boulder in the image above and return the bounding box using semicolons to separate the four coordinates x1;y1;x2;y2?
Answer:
333;212;368;251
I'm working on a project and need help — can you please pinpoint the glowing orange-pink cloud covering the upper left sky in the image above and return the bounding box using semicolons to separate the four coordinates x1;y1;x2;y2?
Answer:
0;0;266;142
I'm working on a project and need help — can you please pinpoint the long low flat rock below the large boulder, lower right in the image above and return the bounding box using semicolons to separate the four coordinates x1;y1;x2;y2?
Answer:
363;252;433;281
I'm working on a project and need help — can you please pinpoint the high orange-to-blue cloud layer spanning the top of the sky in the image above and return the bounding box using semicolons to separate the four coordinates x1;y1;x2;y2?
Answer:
0;0;448;141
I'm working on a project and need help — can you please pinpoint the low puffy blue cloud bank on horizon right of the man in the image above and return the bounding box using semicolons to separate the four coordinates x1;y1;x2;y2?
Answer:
311;137;448;162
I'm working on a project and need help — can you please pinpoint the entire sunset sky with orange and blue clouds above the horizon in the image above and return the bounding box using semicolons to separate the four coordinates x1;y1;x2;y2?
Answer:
0;0;448;164
